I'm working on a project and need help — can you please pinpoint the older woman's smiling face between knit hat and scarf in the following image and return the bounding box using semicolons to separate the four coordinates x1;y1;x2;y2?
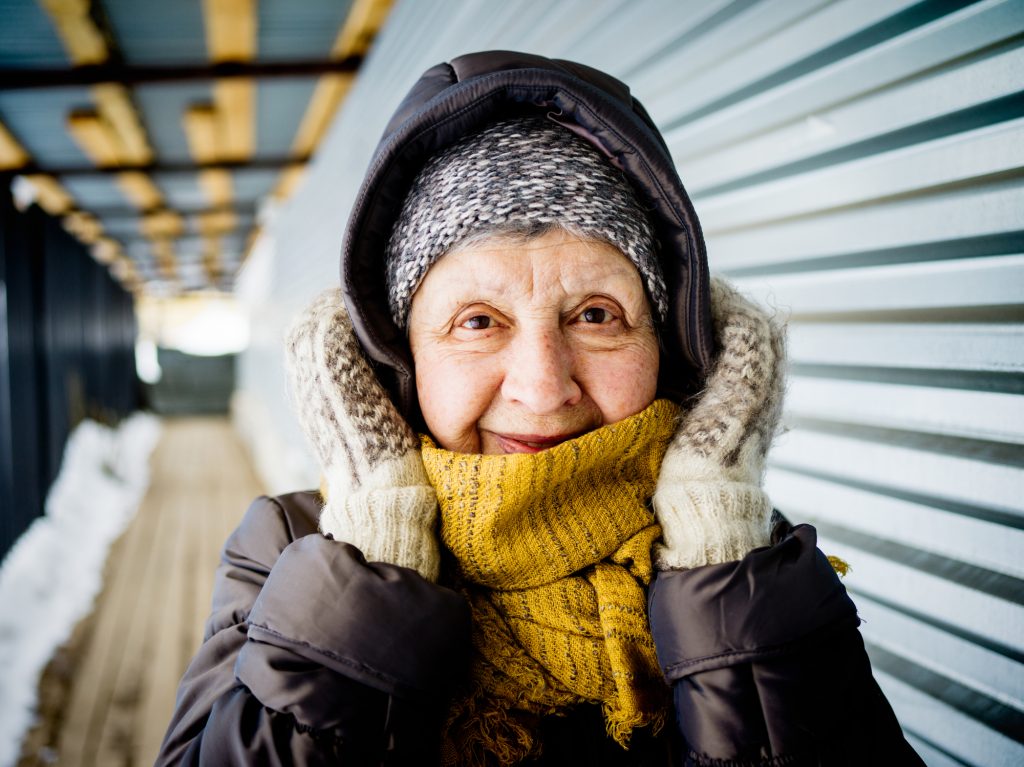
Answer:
409;229;658;454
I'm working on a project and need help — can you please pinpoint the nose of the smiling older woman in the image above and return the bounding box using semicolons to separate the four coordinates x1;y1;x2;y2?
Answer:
502;330;583;415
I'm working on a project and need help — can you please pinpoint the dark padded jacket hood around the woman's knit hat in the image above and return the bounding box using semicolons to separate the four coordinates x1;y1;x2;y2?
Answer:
341;51;713;424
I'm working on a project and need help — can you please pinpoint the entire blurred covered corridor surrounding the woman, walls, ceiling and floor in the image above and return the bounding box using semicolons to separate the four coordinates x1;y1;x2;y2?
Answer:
0;0;1024;767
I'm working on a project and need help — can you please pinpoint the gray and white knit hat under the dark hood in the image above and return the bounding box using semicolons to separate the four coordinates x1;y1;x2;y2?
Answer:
386;118;669;328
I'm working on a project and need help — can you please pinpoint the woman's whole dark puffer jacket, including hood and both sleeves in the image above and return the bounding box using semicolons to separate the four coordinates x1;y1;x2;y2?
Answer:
158;52;922;767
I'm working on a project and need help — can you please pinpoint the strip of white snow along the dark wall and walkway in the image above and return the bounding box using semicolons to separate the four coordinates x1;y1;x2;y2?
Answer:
0;413;160;767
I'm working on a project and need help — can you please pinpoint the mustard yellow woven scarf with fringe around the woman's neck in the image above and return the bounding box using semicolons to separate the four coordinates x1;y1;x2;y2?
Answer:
423;399;678;765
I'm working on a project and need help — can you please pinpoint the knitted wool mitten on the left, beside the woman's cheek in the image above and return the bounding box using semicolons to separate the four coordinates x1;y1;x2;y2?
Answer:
287;290;439;581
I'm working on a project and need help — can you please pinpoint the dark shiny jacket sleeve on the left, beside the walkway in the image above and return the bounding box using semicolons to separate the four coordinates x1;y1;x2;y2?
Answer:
157;494;469;767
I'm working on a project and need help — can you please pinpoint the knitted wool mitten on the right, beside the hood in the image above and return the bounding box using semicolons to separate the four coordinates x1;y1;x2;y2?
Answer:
653;279;785;570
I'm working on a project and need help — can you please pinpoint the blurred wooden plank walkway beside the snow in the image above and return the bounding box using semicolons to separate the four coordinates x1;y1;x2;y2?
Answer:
23;418;262;767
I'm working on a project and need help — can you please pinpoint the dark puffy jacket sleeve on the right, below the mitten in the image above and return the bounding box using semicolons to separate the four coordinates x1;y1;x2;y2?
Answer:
649;525;924;767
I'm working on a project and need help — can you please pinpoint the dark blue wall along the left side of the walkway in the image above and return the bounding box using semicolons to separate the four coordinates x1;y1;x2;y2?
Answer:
0;191;139;557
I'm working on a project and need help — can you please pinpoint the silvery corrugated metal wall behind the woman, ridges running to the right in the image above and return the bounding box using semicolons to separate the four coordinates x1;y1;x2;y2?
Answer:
240;0;1024;767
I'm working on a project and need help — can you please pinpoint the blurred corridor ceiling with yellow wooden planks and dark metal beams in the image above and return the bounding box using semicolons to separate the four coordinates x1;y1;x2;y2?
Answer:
0;0;391;296
